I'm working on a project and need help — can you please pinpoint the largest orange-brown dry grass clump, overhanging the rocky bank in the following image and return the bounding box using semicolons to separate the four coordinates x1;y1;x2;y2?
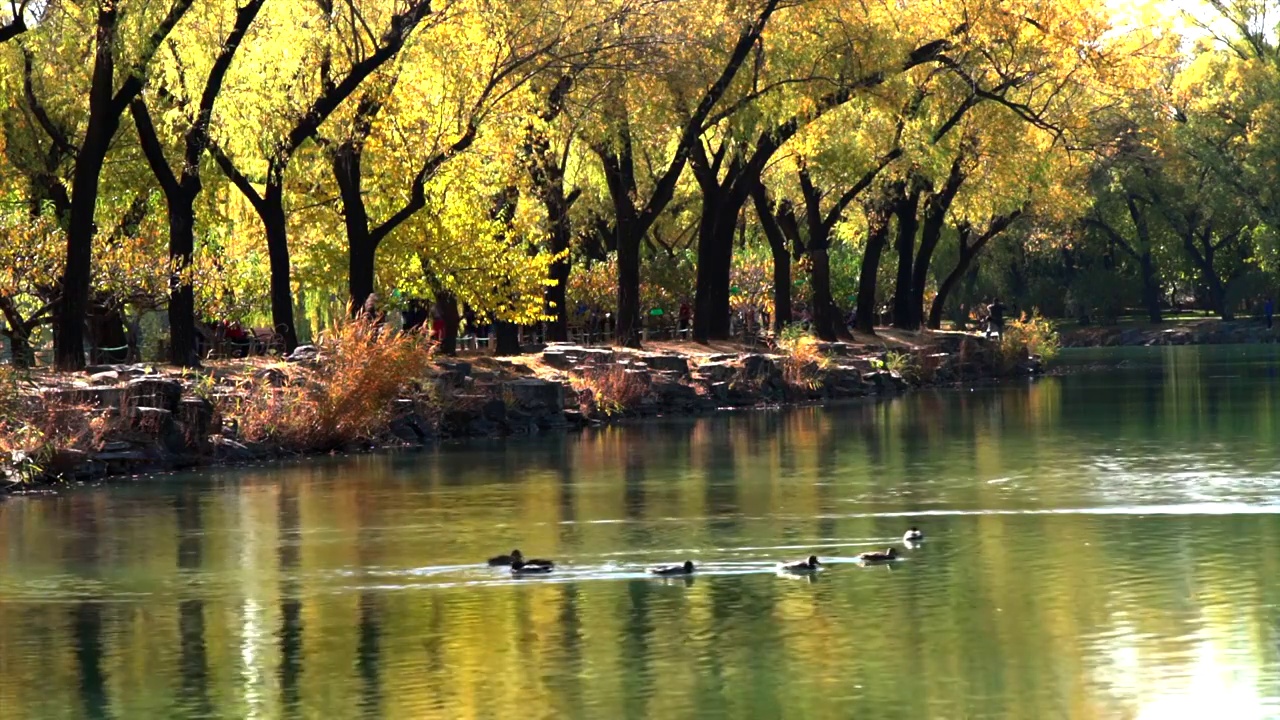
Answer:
219;319;433;451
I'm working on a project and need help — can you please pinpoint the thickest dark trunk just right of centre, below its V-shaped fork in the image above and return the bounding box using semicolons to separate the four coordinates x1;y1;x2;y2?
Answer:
694;204;737;342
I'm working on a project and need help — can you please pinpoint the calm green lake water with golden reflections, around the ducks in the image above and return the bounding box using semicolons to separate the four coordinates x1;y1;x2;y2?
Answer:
0;348;1280;720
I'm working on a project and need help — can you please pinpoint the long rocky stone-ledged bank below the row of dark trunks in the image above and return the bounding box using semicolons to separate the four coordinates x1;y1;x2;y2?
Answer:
0;333;1043;497
